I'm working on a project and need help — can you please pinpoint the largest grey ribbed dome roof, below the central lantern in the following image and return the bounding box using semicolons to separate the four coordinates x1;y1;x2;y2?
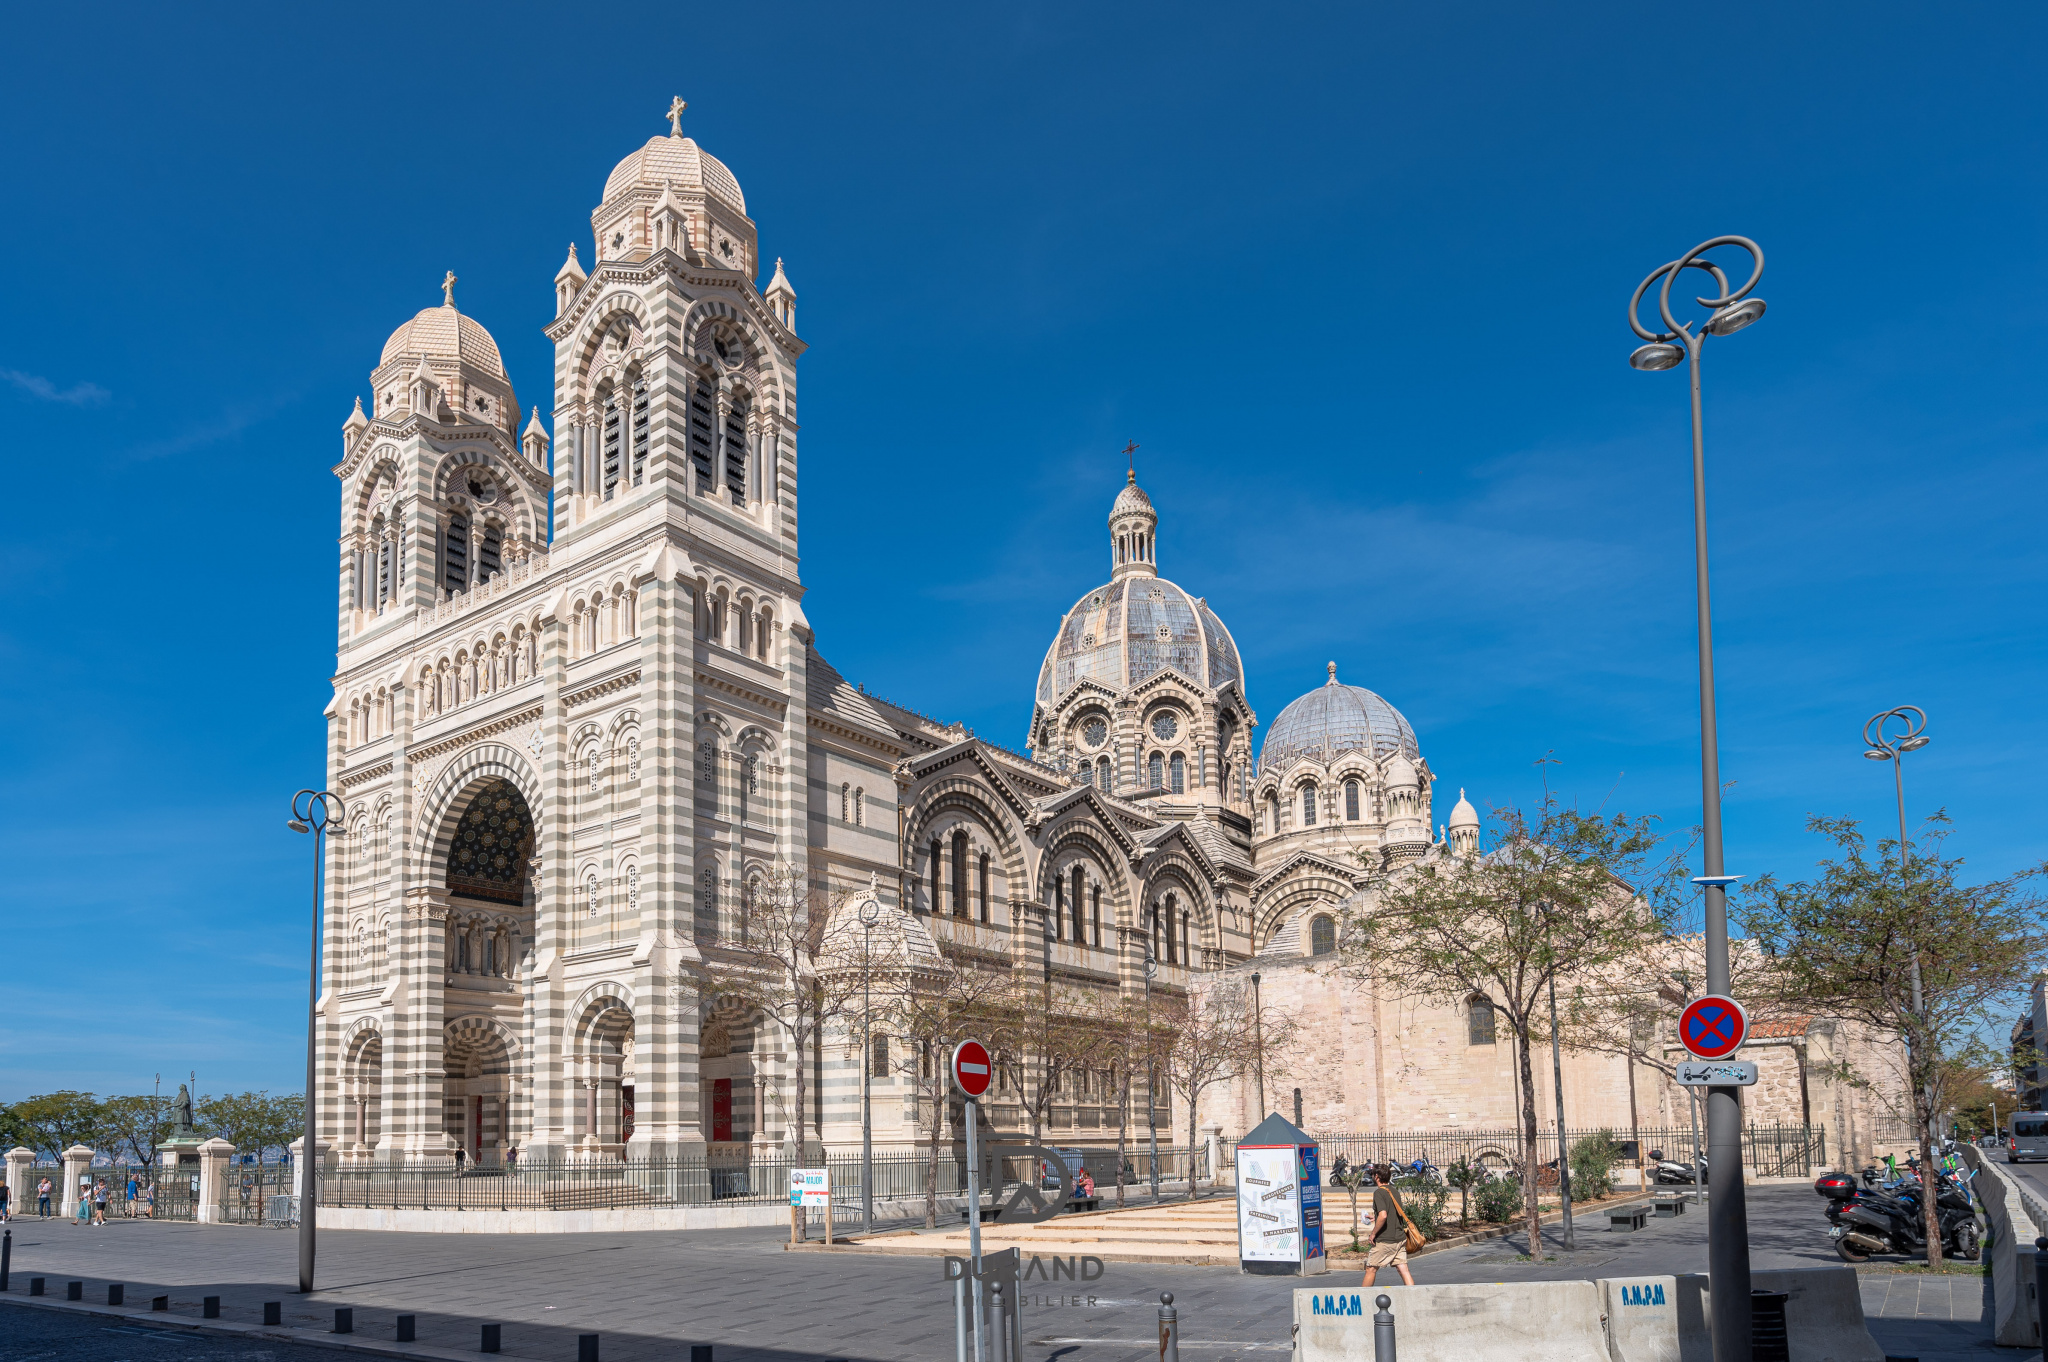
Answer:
1038;578;1245;705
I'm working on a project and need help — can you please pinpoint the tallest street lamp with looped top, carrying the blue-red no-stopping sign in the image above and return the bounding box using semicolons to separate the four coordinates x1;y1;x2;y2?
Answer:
1628;236;1763;1362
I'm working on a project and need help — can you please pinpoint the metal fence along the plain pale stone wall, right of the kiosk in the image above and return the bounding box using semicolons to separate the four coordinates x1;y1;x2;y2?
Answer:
1231;1122;1827;1182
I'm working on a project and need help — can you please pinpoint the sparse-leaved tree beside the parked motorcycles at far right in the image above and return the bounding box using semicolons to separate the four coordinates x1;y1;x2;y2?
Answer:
1743;813;2048;1266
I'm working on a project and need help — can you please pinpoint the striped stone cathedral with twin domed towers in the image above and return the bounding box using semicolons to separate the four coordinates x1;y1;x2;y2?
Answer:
317;100;1477;1165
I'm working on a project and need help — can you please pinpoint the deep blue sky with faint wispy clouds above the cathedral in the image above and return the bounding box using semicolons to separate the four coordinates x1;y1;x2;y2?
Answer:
0;4;2048;1100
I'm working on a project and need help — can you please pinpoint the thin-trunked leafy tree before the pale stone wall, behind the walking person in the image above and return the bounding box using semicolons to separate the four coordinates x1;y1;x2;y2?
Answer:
1337;770;1683;1258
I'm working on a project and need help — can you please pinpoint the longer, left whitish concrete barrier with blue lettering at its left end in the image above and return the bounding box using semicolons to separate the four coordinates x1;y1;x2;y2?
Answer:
1294;1278;1613;1362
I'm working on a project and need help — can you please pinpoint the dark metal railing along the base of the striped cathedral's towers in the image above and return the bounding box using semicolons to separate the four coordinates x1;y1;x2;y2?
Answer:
317;1147;1208;1221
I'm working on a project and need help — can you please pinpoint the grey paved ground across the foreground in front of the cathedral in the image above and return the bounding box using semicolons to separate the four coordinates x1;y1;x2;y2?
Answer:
0;1186;2038;1362
